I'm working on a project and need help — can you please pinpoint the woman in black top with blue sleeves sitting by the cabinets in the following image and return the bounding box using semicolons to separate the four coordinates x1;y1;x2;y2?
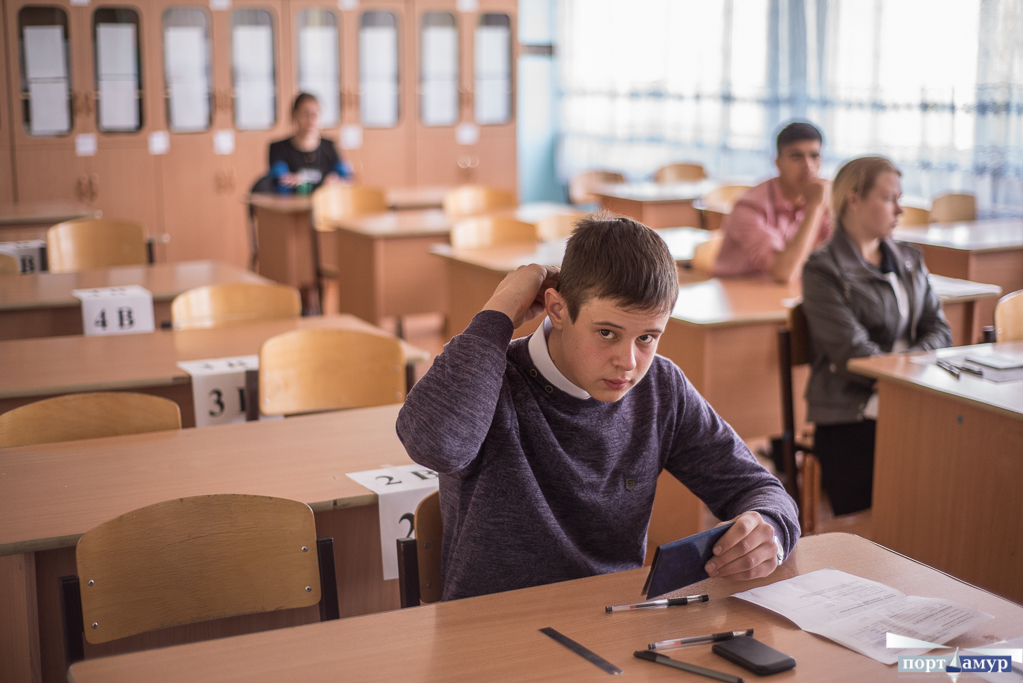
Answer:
270;92;352;193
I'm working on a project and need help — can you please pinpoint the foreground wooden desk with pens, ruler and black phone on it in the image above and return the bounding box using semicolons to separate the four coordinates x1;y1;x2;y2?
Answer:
69;534;1023;683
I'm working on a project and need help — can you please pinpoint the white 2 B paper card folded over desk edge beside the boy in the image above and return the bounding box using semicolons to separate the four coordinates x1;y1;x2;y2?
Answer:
348;465;439;581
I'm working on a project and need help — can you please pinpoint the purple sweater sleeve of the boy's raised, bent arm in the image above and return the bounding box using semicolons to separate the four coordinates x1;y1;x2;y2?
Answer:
396;311;513;472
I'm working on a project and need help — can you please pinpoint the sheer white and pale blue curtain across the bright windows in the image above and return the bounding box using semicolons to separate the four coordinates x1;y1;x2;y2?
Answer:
558;0;1023;216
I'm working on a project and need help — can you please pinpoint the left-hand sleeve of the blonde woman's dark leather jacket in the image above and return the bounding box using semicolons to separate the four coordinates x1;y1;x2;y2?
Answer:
803;260;884;386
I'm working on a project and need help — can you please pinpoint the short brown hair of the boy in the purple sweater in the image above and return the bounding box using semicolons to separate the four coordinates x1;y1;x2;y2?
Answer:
558;212;678;322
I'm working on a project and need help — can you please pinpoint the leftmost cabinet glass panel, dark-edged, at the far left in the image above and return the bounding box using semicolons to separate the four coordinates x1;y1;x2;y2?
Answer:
17;7;72;135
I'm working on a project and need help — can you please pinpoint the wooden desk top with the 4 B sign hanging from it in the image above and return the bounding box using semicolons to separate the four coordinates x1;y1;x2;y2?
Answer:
0;261;269;311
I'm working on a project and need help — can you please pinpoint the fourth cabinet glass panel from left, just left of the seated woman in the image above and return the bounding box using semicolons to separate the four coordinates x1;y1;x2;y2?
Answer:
231;9;277;131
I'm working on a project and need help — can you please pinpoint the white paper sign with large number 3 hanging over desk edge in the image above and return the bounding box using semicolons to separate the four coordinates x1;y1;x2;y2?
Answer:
178;356;259;426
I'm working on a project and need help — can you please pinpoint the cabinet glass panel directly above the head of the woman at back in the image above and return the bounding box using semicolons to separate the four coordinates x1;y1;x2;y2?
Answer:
295;9;341;128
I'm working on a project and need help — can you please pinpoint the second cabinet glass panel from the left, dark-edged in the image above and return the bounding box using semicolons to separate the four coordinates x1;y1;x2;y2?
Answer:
92;7;142;132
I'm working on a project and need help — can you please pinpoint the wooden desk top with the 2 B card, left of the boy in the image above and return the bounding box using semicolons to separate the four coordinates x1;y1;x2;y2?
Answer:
0;405;411;555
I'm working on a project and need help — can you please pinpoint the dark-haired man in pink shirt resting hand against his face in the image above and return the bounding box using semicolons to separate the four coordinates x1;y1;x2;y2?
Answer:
714;123;832;282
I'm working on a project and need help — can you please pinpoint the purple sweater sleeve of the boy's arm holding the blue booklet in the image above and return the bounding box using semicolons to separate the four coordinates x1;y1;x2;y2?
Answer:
665;372;800;555
